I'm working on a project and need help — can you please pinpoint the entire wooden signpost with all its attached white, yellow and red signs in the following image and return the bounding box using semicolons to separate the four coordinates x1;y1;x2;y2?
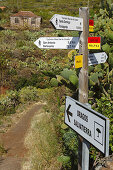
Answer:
34;7;109;170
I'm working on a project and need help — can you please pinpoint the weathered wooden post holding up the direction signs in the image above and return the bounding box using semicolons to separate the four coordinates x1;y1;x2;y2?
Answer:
78;7;89;170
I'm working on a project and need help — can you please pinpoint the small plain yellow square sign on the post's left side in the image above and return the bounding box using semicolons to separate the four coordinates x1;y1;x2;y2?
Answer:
74;55;83;68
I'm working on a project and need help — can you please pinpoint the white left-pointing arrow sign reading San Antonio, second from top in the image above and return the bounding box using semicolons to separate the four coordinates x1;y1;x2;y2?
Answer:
34;37;79;49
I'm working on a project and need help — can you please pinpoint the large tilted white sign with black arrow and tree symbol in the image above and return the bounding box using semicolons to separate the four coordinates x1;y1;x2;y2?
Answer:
65;97;109;153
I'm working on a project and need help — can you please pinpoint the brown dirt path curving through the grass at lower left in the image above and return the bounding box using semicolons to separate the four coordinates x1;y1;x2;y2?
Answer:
0;104;43;170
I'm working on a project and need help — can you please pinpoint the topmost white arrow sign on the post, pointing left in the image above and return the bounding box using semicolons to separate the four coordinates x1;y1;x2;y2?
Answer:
50;14;83;31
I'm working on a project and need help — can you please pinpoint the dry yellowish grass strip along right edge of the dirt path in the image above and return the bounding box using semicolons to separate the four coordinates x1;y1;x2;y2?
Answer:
23;110;61;170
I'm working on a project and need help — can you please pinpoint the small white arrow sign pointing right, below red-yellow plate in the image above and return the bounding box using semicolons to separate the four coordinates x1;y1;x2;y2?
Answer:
88;52;108;66
